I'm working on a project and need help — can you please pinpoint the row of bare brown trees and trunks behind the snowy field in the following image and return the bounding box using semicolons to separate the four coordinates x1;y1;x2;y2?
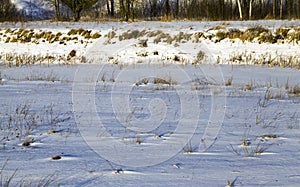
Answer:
0;0;300;21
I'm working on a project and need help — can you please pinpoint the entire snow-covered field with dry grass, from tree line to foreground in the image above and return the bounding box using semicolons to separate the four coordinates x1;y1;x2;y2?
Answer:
0;21;300;186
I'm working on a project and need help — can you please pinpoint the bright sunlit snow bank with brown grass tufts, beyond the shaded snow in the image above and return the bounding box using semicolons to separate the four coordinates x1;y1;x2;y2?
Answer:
0;21;300;69
